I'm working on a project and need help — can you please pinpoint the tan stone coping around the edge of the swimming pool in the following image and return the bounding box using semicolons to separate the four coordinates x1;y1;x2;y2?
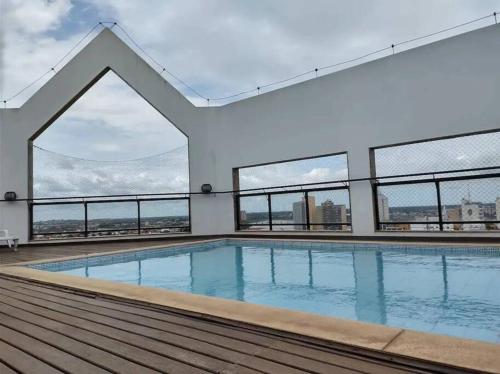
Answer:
0;238;500;373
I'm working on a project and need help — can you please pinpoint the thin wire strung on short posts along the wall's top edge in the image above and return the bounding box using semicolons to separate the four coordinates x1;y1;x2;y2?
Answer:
2;12;497;106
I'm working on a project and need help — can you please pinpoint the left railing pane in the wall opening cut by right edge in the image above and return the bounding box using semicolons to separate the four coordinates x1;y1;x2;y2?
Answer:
377;183;439;231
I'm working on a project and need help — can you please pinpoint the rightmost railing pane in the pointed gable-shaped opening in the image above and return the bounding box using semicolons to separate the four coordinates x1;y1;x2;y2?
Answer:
141;199;189;234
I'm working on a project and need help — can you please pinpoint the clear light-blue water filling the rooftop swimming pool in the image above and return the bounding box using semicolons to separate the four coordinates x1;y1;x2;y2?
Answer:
32;240;500;343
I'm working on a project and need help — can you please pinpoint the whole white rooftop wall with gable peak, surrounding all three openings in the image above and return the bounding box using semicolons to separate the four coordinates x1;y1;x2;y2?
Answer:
0;26;500;241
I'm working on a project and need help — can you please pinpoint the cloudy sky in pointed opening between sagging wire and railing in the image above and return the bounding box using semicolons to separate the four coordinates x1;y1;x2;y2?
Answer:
33;146;189;197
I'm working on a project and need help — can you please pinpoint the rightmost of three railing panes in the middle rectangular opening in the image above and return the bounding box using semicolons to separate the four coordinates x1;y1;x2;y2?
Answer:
309;189;351;231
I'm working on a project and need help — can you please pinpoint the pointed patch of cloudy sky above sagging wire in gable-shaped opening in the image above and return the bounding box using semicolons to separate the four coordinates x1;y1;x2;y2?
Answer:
35;72;187;160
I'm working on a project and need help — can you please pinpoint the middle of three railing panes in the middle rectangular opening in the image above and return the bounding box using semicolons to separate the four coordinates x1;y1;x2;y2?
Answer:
271;192;304;231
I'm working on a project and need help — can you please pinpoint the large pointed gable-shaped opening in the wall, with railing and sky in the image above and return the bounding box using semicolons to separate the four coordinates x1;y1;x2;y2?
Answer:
30;71;190;239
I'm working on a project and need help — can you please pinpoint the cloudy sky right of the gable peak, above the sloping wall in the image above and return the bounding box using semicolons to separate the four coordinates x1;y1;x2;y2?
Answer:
79;0;499;104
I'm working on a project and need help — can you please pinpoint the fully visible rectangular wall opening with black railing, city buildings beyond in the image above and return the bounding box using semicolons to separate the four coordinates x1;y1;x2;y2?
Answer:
235;153;351;231
